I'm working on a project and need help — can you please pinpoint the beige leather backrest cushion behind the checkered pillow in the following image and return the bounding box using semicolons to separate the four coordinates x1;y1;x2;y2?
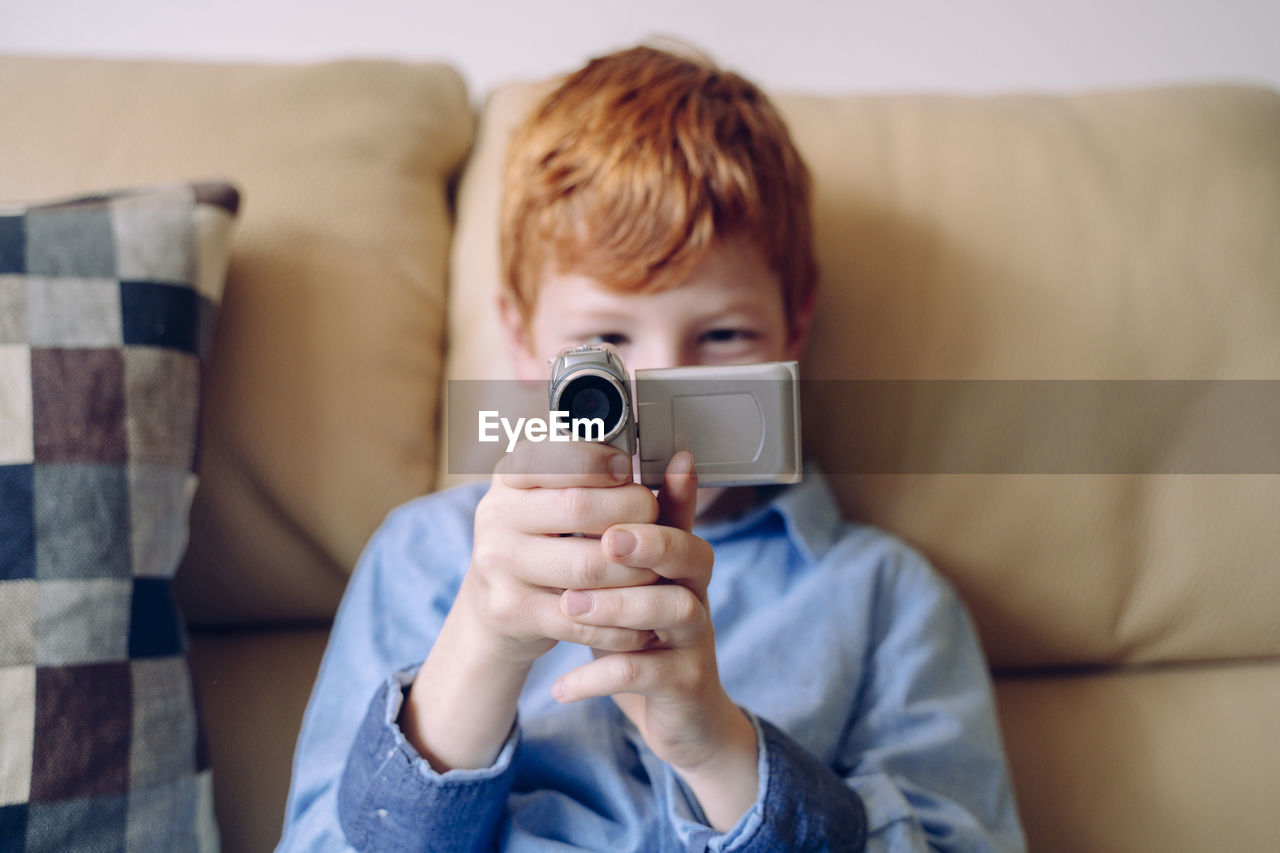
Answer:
0;58;475;622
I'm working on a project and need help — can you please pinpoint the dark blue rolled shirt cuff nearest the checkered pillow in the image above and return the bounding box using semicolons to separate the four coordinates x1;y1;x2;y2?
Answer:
338;670;520;850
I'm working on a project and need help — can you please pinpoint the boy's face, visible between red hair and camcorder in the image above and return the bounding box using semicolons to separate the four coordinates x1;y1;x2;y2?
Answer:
502;234;808;379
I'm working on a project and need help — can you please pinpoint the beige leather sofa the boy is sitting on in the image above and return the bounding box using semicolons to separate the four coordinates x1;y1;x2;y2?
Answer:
0;58;1280;852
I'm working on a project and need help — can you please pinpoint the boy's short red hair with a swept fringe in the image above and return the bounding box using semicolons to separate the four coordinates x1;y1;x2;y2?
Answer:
500;47;817;325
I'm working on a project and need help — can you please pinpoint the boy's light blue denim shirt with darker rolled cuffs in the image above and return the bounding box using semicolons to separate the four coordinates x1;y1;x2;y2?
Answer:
279;474;1024;853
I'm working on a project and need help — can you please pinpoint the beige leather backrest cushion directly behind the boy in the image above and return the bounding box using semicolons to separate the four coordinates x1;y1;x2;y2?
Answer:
442;79;1280;667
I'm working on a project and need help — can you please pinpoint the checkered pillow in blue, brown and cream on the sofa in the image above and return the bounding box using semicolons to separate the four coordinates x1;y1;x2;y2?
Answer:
0;184;238;852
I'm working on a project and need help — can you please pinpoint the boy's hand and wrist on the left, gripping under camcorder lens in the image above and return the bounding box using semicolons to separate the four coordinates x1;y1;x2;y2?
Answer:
399;442;658;772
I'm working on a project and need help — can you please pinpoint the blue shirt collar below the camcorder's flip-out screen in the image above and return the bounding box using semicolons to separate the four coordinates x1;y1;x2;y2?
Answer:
694;462;844;562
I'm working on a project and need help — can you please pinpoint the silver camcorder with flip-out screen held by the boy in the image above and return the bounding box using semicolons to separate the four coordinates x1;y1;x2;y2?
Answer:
548;345;801;488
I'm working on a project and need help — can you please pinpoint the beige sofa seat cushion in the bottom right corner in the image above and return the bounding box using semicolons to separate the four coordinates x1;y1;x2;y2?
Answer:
996;660;1280;853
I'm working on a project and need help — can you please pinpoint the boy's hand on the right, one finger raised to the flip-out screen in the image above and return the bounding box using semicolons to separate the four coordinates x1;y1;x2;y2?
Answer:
553;452;758;831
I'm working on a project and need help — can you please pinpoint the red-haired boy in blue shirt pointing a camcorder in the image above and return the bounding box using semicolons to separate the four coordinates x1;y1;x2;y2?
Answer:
280;49;1023;850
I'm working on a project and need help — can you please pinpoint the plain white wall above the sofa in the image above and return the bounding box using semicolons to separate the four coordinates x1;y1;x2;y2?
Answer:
0;0;1280;93
